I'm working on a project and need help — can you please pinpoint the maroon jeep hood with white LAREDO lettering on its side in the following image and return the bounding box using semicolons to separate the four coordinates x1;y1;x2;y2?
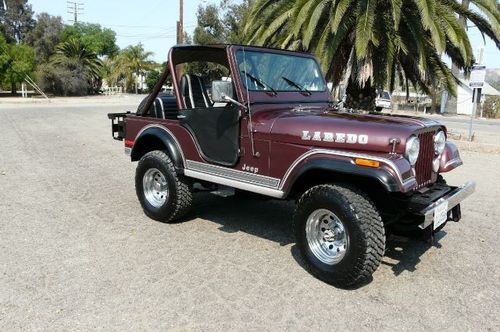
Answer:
257;109;441;153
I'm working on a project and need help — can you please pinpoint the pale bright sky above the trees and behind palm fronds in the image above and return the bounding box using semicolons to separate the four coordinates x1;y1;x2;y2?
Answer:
29;0;500;68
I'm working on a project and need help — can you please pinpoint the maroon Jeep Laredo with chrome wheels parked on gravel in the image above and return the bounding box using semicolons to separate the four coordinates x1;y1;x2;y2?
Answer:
109;45;475;287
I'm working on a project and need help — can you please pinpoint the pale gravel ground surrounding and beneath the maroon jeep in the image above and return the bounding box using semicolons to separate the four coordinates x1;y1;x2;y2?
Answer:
0;104;500;331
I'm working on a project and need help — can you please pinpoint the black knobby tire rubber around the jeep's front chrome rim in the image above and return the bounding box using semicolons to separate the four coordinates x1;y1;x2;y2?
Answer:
293;184;385;288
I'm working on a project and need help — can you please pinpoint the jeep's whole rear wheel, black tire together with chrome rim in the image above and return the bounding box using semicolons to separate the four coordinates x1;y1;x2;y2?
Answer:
135;151;193;222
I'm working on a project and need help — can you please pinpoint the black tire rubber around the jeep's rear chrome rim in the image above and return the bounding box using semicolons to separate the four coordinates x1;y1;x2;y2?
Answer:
135;151;193;223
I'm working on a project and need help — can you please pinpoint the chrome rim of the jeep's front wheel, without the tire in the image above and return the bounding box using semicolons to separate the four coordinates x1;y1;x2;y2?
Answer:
306;209;349;265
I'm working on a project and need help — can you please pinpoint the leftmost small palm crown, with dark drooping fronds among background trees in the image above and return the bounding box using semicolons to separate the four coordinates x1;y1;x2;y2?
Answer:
51;38;102;81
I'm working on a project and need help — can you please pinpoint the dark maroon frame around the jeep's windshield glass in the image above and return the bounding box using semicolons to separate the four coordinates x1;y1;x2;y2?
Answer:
234;47;328;95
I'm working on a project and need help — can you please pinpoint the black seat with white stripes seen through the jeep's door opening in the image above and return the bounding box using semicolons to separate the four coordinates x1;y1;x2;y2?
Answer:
180;74;213;108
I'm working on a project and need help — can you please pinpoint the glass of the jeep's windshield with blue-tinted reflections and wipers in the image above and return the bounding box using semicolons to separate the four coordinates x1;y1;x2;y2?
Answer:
236;50;326;94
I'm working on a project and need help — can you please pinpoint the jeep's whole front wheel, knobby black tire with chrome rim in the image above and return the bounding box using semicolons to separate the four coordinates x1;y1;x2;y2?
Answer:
293;185;385;288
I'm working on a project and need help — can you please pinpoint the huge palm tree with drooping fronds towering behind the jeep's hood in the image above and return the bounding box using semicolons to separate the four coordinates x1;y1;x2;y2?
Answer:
244;0;500;108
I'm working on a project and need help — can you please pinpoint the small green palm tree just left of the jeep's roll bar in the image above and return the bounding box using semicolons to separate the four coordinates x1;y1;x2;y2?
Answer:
111;44;154;94
